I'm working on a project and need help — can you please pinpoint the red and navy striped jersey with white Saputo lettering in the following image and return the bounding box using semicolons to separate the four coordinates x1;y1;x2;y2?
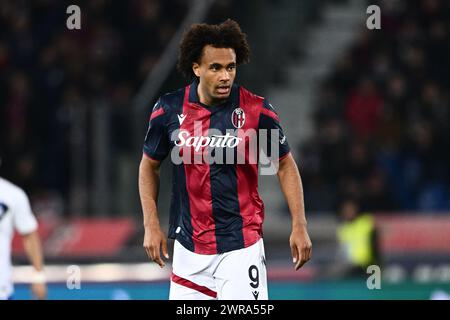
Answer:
143;81;290;254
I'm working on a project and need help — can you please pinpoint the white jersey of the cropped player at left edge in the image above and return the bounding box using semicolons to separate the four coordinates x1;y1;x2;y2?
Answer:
0;178;38;300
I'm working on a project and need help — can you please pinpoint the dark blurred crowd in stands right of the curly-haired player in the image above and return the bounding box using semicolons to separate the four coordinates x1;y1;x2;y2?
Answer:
300;0;450;212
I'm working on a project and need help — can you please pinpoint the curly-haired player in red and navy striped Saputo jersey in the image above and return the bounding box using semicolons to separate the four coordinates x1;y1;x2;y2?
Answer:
139;20;311;300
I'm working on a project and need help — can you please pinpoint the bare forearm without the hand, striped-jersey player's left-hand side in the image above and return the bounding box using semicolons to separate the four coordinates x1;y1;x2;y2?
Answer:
139;156;163;228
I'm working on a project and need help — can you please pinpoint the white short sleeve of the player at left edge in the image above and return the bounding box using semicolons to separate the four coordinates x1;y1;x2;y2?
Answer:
12;190;38;235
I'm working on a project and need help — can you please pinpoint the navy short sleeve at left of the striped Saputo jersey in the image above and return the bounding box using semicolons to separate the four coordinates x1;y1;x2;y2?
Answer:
143;99;170;161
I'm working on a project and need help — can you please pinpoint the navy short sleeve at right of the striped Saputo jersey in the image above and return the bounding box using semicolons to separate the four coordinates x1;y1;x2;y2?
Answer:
259;100;290;160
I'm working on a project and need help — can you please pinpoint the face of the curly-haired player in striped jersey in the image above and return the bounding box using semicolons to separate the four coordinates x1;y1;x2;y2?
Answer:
193;45;236;105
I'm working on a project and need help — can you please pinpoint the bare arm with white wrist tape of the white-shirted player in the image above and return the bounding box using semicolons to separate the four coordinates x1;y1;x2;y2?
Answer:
22;231;47;300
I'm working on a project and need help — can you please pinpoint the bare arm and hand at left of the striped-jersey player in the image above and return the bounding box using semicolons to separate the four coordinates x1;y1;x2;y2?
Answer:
139;154;169;268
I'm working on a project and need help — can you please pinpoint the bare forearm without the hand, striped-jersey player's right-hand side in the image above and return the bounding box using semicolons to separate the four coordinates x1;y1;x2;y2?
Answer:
278;155;306;227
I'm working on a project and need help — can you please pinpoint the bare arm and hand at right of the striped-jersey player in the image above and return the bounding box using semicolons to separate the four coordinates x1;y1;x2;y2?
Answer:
277;153;312;270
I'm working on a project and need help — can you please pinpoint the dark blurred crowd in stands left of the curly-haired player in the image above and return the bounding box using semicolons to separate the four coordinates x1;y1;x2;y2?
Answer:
0;0;187;215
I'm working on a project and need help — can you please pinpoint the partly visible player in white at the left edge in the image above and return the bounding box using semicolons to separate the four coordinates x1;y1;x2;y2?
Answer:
0;165;47;300
